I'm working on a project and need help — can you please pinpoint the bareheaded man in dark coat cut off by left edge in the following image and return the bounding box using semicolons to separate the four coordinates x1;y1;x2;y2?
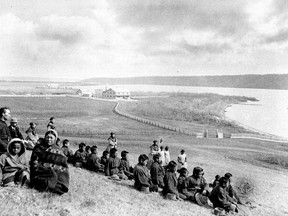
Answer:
0;107;11;155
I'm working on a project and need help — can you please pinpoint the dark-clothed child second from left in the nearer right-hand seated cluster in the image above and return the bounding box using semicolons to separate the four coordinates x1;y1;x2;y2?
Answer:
150;153;165;192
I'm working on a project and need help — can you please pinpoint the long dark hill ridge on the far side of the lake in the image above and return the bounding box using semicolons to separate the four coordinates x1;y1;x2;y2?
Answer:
82;74;288;89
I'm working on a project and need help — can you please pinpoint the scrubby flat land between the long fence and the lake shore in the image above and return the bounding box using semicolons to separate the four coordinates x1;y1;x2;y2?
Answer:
121;93;256;135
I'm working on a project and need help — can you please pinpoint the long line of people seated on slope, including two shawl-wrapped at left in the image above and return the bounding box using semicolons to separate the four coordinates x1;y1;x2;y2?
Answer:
0;124;241;212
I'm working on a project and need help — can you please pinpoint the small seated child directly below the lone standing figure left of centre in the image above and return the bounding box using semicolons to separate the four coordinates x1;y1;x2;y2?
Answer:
105;148;124;180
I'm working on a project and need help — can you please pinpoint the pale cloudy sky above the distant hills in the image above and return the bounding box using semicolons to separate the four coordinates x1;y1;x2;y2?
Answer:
0;0;288;80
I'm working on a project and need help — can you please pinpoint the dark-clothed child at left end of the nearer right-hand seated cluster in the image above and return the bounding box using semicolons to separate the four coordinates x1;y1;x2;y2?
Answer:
133;154;151;193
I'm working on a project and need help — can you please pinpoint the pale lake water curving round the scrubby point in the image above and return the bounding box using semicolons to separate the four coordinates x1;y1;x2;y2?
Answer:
79;85;288;138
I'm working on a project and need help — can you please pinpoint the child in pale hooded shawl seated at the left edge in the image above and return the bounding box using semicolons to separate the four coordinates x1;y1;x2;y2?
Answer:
0;138;30;186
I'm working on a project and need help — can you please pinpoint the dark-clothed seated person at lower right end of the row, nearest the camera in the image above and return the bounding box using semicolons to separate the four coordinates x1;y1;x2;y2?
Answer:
209;177;238;212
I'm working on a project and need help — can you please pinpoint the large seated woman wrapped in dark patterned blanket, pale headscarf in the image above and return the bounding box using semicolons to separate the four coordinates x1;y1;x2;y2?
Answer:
30;129;69;195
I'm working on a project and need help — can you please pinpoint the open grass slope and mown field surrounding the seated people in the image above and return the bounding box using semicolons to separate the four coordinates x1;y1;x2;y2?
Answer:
0;97;288;216
